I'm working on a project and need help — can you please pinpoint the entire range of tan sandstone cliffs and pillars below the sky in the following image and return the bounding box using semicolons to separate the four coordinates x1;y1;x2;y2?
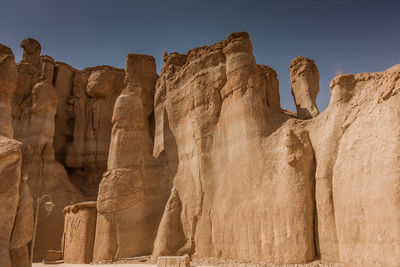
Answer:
0;32;400;267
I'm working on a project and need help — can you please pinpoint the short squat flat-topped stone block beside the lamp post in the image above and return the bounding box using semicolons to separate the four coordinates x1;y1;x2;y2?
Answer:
63;201;97;263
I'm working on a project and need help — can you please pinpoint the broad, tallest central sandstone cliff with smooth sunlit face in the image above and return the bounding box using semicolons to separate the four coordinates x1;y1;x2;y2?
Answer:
153;33;315;263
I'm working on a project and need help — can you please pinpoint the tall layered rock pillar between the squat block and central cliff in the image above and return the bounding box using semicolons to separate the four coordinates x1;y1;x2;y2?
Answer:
93;54;170;261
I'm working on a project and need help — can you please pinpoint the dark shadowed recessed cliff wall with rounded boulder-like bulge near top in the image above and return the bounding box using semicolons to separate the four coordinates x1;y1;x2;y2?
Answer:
64;66;125;199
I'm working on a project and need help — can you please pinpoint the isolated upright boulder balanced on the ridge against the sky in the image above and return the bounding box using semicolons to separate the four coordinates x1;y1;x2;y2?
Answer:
289;57;319;119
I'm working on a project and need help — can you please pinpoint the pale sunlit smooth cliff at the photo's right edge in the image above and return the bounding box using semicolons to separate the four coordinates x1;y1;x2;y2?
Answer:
316;65;400;266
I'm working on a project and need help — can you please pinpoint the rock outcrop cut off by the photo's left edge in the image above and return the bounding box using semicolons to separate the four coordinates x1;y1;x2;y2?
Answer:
0;44;33;267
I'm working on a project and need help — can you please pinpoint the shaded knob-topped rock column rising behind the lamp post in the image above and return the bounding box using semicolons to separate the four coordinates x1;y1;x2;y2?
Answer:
13;39;82;259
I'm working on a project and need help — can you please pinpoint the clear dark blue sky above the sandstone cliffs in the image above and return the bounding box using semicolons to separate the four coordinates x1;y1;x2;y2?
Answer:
0;0;400;111
